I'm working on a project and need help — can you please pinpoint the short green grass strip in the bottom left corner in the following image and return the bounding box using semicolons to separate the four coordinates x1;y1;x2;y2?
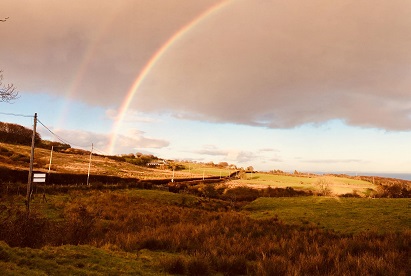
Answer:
0;241;168;275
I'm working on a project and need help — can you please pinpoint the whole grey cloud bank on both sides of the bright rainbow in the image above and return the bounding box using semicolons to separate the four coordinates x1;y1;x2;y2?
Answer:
0;0;411;130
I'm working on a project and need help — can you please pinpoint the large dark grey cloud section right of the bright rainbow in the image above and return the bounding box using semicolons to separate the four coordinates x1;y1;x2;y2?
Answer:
134;0;411;130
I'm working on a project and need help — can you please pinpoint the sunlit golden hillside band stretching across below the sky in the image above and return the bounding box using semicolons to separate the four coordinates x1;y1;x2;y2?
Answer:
0;140;411;197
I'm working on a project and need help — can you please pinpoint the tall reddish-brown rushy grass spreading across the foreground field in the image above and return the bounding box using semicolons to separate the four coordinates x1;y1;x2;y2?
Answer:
0;191;411;275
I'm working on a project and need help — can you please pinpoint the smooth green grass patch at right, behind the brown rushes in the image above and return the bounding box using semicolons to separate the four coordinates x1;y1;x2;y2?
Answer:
243;197;411;233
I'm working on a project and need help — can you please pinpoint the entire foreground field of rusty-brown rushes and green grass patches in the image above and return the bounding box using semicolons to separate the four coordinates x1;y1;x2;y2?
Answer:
0;189;411;275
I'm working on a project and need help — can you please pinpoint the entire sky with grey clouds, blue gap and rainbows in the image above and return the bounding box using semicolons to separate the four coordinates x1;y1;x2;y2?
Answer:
0;0;411;173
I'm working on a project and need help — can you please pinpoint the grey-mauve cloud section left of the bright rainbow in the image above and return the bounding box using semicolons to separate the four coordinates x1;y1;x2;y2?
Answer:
0;0;219;107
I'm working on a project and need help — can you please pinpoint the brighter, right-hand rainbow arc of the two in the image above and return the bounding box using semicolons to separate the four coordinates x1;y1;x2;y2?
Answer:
108;0;234;154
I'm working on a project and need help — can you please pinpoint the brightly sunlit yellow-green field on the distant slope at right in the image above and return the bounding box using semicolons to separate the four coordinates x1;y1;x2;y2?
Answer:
230;173;376;196
